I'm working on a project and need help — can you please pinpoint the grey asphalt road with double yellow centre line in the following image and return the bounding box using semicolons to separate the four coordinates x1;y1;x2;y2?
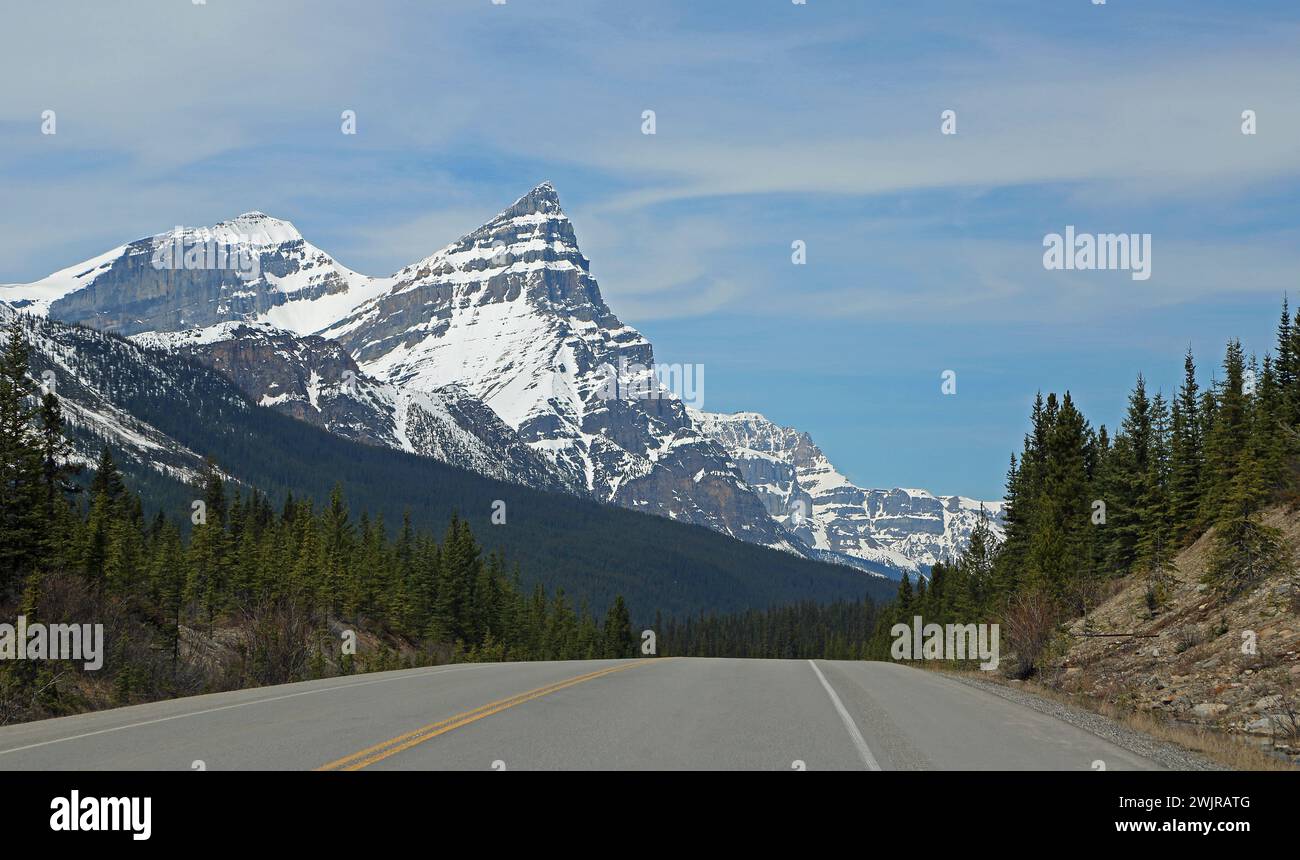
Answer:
0;657;1157;770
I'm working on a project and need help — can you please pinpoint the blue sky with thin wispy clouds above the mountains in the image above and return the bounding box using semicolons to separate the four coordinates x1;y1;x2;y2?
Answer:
0;0;1300;498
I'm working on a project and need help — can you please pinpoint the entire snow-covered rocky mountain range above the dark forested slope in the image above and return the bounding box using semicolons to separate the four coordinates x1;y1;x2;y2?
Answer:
0;183;1000;574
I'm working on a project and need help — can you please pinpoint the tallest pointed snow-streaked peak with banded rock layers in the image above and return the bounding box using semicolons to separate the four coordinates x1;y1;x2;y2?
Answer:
321;183;800;551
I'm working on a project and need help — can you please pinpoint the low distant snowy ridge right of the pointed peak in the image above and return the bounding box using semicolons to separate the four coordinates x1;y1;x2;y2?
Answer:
690;409;1004;573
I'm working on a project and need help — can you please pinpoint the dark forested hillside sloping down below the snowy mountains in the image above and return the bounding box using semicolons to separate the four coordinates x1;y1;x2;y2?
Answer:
5;317;888;624
